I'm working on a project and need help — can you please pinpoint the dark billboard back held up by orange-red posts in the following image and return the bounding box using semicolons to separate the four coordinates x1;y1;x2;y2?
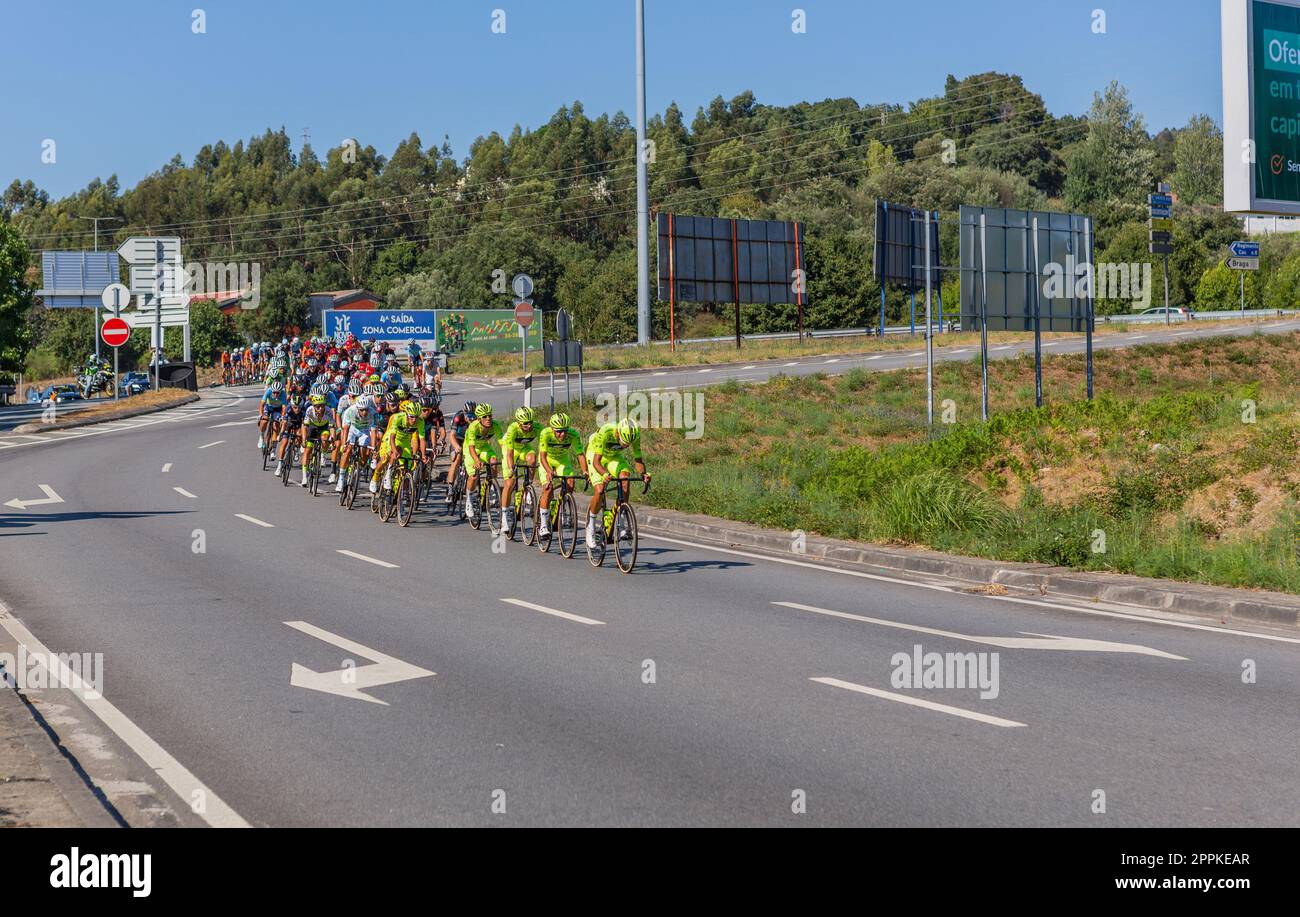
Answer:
658;213;809;306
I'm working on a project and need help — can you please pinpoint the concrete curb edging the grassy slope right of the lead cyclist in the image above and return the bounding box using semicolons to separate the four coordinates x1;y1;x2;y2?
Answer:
637;507;1300;627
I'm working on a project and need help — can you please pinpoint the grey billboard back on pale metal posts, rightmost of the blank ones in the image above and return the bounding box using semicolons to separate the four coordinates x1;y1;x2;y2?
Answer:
961;207;1092;332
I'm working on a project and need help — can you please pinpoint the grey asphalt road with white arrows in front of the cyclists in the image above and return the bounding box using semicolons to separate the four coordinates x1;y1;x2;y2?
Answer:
0;328;1300;826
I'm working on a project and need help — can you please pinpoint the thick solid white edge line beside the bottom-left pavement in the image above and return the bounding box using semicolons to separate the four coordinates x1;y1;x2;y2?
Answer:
0;602;252;827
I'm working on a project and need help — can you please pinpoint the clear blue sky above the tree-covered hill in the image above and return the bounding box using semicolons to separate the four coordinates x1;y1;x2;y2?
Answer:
0;0;1223;198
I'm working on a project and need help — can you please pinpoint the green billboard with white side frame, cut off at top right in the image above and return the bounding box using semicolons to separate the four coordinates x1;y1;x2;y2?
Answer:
1219;0;1300;215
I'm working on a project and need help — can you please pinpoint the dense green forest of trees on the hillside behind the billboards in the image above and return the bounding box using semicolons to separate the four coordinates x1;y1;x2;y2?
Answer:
0;73;1258;369
